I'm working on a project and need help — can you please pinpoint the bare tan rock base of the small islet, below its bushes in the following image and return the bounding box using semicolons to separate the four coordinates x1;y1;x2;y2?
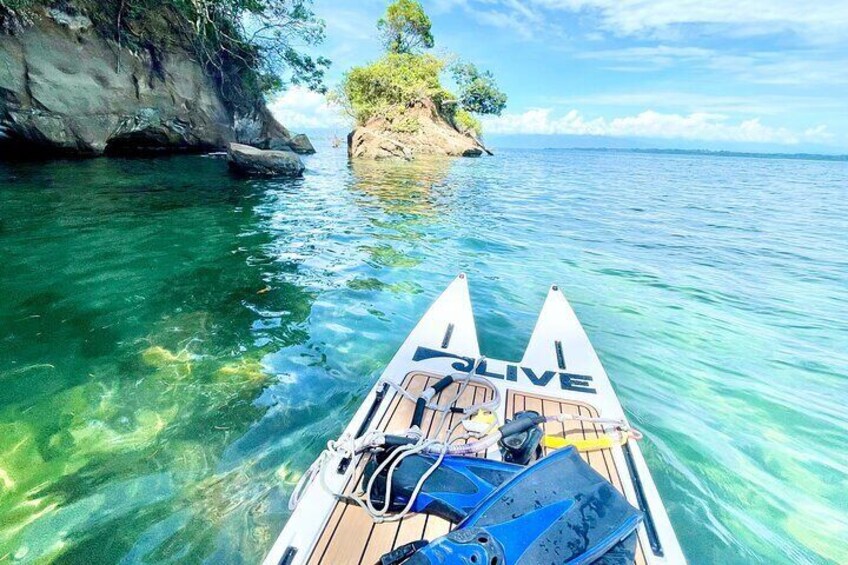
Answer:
347;99;488;159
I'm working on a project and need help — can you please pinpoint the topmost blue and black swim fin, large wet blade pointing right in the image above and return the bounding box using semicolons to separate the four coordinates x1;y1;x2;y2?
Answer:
406;448;642;565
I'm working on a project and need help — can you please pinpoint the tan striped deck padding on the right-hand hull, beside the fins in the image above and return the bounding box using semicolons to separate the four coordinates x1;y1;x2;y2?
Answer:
506;391;647;565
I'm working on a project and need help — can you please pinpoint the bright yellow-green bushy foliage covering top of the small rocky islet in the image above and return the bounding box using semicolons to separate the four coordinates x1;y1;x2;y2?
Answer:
334;53;450;124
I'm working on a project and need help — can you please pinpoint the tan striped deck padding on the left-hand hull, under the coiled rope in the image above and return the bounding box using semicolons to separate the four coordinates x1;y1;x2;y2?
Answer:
309;373;493;565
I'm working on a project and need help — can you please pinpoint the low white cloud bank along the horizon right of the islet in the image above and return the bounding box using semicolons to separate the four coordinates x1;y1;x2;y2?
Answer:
484;108;832;145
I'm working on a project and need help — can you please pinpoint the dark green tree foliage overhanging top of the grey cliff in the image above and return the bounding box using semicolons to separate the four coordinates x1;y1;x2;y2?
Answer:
0;0;330;107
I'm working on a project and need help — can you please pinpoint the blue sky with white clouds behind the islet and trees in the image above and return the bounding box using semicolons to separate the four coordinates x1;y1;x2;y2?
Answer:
271;0;848;153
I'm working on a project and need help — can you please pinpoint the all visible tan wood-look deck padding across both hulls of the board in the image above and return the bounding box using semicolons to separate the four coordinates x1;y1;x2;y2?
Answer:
309;372;646;565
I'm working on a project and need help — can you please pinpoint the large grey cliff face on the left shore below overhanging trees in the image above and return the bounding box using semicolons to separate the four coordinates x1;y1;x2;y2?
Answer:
0;9;312;157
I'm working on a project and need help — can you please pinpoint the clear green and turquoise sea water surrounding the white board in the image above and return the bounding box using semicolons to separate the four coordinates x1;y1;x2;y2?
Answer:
0;147;848;563
